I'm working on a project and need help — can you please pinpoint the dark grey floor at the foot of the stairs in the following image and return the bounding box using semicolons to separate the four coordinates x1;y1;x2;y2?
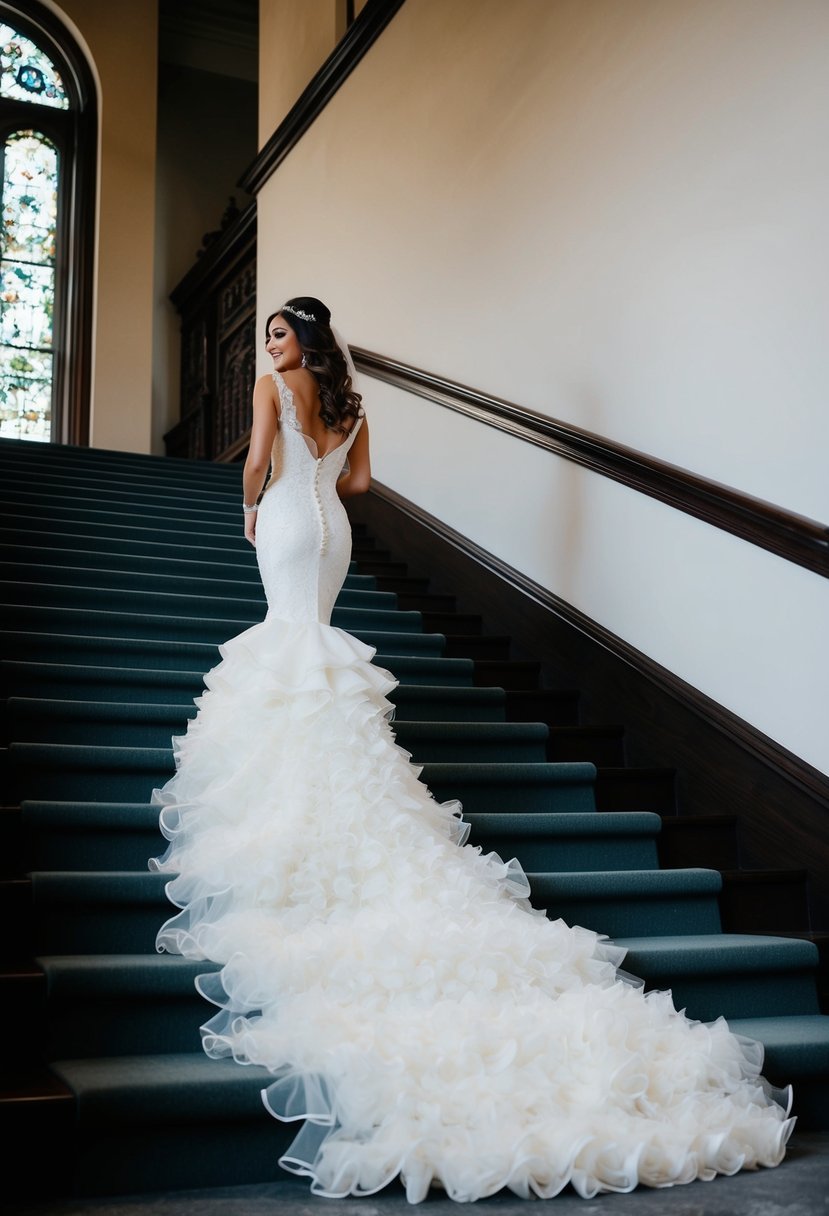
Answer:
9;1132;829;1216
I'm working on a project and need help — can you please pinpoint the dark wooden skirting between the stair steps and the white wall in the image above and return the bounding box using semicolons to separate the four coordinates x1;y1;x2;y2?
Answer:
348;483;829;929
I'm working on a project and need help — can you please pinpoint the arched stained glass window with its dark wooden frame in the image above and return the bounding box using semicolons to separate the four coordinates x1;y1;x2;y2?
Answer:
0;0;97;444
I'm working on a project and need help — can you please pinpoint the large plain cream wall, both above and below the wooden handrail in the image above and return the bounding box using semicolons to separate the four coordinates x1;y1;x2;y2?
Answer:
258;0;829;771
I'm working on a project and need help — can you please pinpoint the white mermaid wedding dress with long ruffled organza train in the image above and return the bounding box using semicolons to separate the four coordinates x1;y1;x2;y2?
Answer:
150;373;794;1203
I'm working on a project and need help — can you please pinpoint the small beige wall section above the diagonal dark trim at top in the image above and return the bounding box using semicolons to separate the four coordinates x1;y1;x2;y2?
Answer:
259;0;343;147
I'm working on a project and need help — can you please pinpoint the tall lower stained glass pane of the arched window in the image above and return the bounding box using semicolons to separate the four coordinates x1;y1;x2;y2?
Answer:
0;131;58;440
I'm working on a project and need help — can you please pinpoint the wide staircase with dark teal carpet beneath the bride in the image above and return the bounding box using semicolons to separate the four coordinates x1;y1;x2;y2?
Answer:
0;440;829;1197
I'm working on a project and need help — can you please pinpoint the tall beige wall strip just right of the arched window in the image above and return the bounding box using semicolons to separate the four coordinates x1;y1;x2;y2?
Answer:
50;0;158;452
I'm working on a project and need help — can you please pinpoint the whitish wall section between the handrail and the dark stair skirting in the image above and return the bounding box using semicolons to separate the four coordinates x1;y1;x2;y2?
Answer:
362;379;829;771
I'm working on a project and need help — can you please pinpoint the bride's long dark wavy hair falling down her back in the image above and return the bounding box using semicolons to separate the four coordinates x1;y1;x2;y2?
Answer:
265;295;362;433
